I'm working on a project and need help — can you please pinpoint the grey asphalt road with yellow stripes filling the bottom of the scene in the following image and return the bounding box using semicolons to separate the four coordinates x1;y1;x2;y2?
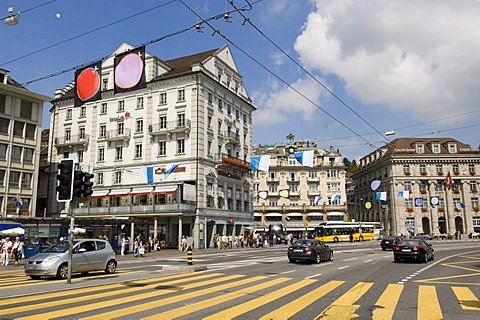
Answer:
0;240;480;319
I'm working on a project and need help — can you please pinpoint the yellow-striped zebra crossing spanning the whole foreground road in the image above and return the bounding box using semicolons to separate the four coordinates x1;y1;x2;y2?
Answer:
0;272;480;320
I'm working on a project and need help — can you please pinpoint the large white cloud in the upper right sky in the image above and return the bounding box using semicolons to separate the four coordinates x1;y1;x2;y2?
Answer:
295;0;480;119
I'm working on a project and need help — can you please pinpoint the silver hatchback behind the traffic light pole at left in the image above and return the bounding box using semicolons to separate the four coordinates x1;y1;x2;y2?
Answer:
25;239;117;279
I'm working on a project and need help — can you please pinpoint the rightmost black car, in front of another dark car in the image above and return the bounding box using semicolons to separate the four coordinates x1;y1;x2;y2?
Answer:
393;239;435;263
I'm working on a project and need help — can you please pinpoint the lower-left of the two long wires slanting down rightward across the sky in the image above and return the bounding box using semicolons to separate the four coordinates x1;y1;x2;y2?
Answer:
178;0;376;148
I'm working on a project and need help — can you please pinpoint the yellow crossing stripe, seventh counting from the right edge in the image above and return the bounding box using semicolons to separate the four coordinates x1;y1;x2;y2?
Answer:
142;278;290;320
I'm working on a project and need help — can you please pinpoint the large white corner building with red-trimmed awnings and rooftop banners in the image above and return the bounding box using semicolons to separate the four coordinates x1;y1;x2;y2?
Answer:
50;43;255;248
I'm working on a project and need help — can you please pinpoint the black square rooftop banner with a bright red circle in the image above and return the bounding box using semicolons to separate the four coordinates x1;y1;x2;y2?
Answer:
74;60;102;107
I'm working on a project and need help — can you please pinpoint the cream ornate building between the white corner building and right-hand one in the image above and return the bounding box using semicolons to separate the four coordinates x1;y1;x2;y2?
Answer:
253;135;349;233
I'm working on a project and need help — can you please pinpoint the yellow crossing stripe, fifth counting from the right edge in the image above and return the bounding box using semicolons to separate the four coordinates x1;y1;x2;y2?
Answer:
261;281;345;320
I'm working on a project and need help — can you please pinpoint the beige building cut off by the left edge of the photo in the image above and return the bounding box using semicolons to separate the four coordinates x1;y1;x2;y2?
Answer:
0;69;51;218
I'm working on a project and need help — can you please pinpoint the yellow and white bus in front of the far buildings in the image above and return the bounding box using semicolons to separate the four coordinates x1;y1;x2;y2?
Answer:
314;221;380;242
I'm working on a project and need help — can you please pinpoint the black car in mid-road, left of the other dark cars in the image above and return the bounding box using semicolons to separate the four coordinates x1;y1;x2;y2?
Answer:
287;239;333;263
